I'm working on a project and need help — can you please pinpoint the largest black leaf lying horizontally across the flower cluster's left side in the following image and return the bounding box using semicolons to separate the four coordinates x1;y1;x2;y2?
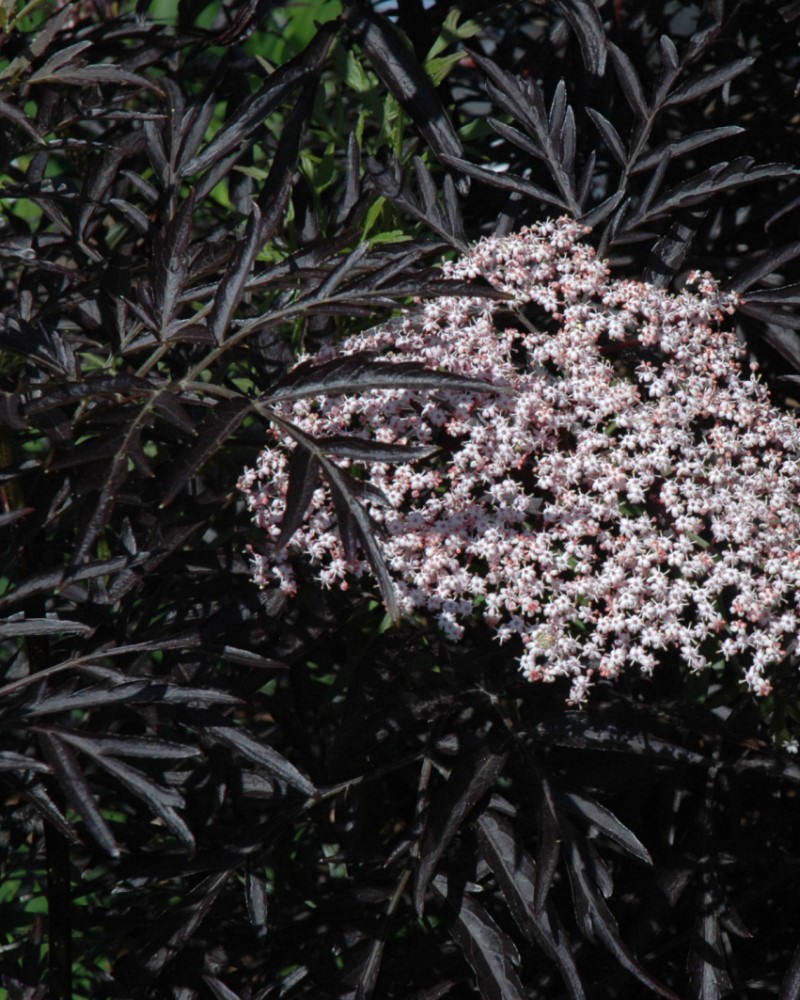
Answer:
264;351;509;404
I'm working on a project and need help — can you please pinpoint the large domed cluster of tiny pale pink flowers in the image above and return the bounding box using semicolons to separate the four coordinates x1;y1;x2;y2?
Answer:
239;219;800;702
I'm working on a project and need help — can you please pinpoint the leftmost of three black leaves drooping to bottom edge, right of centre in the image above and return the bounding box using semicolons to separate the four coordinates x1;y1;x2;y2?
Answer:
433;875;526;1000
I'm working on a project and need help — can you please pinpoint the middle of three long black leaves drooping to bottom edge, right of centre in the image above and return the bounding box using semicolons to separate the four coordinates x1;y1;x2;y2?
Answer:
478;809;586;1000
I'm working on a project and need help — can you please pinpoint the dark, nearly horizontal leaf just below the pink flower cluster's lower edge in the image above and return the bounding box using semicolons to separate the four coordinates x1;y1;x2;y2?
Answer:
532;712;710;767
